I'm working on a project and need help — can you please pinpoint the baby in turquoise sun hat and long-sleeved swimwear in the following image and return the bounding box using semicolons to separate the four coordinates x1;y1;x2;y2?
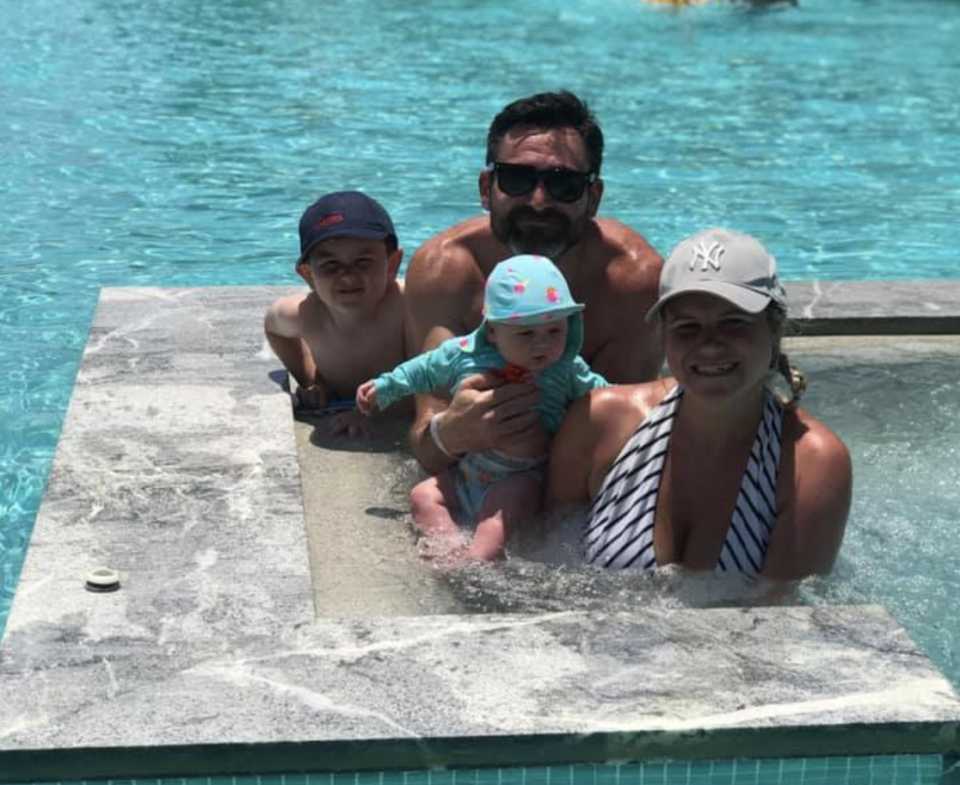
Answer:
357;255;607;567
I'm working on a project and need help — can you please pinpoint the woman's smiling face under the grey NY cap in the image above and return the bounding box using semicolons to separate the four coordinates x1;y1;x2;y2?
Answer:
663;294;774;398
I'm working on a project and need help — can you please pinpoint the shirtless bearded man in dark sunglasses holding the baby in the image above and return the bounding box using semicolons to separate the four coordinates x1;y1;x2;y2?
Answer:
405;92;662;473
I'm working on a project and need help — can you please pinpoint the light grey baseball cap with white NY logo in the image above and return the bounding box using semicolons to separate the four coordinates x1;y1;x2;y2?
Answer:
646;227;787;322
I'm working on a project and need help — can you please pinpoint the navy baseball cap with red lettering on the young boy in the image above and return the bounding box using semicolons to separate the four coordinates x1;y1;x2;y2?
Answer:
297;191;397;264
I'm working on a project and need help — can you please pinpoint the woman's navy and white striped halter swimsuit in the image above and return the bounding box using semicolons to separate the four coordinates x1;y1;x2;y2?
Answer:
583;385;783;573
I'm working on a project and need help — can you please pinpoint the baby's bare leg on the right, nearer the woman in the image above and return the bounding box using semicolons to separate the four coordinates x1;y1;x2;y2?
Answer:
467;474;543;561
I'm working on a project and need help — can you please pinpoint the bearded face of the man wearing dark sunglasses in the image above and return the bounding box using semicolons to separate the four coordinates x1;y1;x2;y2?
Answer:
480;126;603;259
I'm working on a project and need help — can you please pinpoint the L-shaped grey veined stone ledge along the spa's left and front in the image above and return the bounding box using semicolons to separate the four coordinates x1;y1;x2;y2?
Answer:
0;282;960;782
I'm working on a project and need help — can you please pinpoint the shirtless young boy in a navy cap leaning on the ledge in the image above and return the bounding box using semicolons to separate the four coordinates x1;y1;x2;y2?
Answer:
263;191;405;436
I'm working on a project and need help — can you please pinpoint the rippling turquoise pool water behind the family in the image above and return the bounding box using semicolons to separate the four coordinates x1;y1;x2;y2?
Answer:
0;0;960;672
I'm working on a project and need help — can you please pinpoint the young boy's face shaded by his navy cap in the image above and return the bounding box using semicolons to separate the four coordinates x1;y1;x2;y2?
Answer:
297;237;403;311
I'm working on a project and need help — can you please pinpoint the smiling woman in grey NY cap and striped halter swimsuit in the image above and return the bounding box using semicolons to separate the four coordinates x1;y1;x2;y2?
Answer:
547;229;852;580
